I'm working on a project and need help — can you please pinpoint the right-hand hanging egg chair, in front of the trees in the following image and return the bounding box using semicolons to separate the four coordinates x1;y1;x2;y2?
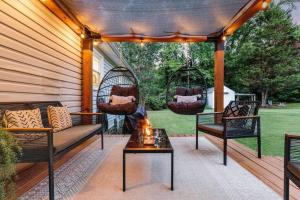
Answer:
166;62;207;115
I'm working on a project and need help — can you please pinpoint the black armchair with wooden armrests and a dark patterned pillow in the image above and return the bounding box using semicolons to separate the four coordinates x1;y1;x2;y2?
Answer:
196;101;261;165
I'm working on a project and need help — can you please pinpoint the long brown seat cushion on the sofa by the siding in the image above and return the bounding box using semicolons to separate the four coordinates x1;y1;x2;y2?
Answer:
53;124;101;153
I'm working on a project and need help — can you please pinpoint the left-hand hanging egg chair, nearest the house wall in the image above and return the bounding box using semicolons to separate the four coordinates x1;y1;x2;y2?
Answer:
97;66;139;115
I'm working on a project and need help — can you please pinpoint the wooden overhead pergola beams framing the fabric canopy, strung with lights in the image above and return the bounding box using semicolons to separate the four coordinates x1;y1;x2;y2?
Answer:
41;0;271;43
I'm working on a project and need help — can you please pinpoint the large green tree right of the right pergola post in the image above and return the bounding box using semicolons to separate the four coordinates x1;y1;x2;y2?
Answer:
225;2;300;106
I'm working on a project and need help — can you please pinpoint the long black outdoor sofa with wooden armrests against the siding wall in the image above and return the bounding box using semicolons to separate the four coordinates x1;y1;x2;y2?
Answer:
0;101;103;200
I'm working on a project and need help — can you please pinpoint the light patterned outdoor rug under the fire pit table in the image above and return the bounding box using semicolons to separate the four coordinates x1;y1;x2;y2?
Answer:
19;136;281;200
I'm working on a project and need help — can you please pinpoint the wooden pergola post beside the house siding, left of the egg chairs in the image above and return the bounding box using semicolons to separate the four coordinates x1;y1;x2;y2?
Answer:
82;39;93;123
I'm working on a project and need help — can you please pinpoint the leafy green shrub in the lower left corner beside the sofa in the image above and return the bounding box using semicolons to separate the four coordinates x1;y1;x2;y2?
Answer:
0;131;21;200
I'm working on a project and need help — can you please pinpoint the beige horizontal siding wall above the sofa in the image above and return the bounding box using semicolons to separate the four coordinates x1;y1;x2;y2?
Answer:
0;0;82;112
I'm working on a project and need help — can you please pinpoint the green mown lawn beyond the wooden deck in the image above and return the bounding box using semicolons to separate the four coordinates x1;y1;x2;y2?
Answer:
148;103;300;156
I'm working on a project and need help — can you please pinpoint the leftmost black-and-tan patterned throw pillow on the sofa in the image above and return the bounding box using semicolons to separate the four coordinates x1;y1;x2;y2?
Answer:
3;108;44;128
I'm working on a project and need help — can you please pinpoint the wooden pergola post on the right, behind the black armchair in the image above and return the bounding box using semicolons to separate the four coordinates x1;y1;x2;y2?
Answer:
214;38;224;112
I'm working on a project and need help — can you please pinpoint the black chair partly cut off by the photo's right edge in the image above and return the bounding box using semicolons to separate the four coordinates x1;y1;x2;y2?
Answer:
284;134;300;200
